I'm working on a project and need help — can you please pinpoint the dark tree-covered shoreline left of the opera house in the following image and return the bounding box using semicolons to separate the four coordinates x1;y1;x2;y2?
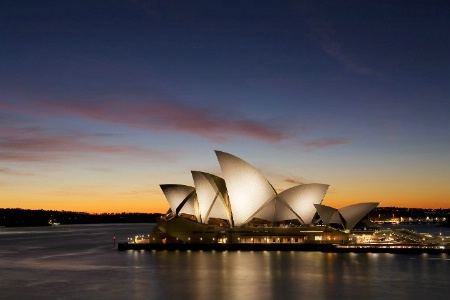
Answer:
0;208;161;227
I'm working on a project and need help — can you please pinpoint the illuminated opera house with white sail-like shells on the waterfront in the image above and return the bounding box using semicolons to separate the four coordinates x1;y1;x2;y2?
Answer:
145;151;378;245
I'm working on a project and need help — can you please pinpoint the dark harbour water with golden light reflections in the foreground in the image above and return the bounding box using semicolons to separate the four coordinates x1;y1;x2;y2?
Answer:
0;224;450;300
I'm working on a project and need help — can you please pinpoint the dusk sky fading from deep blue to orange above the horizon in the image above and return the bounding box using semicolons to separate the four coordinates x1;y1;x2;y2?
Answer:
0;0;450;213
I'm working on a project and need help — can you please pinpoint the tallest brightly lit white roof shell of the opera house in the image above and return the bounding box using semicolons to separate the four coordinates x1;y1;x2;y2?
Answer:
216;151;276;226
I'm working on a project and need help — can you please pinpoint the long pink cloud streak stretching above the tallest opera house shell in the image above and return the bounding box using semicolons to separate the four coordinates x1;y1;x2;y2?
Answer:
4;99;288;142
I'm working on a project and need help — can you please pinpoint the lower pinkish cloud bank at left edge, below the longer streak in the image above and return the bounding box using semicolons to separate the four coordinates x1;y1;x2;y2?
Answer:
0;128;164;162
